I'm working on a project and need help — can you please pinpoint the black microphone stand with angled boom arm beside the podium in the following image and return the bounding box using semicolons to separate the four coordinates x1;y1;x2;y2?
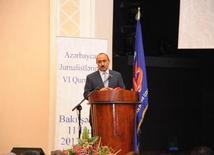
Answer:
72;74;112;138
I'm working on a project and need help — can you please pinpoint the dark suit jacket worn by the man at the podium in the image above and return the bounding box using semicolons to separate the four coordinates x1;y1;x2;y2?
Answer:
83;70;125;99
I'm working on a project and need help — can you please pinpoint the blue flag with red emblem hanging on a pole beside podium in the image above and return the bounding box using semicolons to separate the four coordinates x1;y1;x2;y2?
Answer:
133;9;148;152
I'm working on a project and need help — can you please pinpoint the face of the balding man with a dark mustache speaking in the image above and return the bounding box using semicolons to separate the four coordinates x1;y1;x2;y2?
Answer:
96;54;109;71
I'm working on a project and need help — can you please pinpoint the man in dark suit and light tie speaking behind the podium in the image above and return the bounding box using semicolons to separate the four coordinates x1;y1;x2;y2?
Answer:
83;53;125;99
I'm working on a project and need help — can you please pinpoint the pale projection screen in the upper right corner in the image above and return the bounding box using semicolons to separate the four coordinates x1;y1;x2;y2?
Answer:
178;0;214;49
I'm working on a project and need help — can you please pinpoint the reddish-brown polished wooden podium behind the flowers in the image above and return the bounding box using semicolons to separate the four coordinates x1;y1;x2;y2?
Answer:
89;89;138;155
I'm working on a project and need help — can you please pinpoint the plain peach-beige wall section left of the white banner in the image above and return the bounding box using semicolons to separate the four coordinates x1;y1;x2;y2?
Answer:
0;0;50;154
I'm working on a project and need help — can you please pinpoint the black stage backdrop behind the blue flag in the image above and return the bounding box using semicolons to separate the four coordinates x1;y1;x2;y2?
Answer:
113;0;214;151
